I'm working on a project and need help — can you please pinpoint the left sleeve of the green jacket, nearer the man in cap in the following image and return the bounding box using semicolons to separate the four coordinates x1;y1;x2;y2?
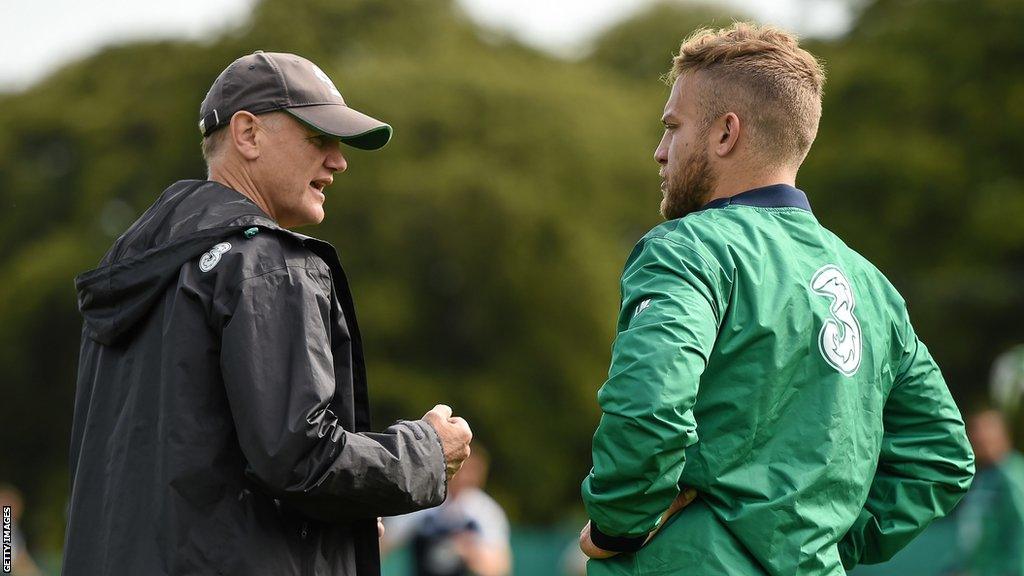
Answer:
583;239;718;551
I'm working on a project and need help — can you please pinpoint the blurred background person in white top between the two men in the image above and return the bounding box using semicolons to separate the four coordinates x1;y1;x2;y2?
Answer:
381;441;512;576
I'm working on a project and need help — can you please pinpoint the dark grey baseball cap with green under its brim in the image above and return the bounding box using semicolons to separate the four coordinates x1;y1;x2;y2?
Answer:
199;50;391;150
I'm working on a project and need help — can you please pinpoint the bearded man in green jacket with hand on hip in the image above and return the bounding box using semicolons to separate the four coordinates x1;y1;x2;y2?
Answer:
581;24;974;576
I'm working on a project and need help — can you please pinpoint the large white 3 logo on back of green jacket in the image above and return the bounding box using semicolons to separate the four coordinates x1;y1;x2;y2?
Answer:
811;264;861;376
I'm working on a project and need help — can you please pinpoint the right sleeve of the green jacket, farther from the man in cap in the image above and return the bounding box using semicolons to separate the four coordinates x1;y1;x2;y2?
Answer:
839;323;974;570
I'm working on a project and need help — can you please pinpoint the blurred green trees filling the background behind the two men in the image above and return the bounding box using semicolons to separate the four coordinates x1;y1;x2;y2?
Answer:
0;0;1024;548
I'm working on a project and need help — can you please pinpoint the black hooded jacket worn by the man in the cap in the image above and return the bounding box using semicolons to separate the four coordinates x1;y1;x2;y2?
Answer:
62;180;446;576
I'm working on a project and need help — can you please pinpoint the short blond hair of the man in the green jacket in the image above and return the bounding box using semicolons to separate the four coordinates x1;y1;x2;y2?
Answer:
666;23;825;167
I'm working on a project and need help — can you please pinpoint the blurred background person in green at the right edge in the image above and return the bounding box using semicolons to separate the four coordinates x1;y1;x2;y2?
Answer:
949;407;1024;576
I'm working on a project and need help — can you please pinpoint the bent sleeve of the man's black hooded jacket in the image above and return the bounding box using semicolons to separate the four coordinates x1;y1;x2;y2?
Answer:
220;266;446;521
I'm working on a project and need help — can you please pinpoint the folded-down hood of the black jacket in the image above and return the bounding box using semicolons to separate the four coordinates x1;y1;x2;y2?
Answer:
75;180;282;345
